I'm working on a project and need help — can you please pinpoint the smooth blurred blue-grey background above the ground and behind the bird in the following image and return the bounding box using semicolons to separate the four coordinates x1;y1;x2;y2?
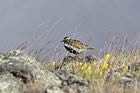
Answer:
0;0;140;51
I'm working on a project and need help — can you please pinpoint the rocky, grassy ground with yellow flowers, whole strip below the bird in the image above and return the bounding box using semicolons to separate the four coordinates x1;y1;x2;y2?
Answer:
0;35;140;93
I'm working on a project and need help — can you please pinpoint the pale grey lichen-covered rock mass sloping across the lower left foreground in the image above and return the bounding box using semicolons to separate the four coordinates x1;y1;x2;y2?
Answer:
0;50;91;93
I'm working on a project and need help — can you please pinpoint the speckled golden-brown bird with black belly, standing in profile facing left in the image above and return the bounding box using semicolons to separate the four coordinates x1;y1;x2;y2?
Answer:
61;36;94;54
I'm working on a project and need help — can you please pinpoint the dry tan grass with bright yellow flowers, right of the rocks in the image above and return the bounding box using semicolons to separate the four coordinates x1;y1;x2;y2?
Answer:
48;49;140;93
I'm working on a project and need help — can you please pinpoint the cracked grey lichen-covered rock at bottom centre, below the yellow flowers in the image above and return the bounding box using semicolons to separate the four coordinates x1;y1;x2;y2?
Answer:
46;70;91;93
